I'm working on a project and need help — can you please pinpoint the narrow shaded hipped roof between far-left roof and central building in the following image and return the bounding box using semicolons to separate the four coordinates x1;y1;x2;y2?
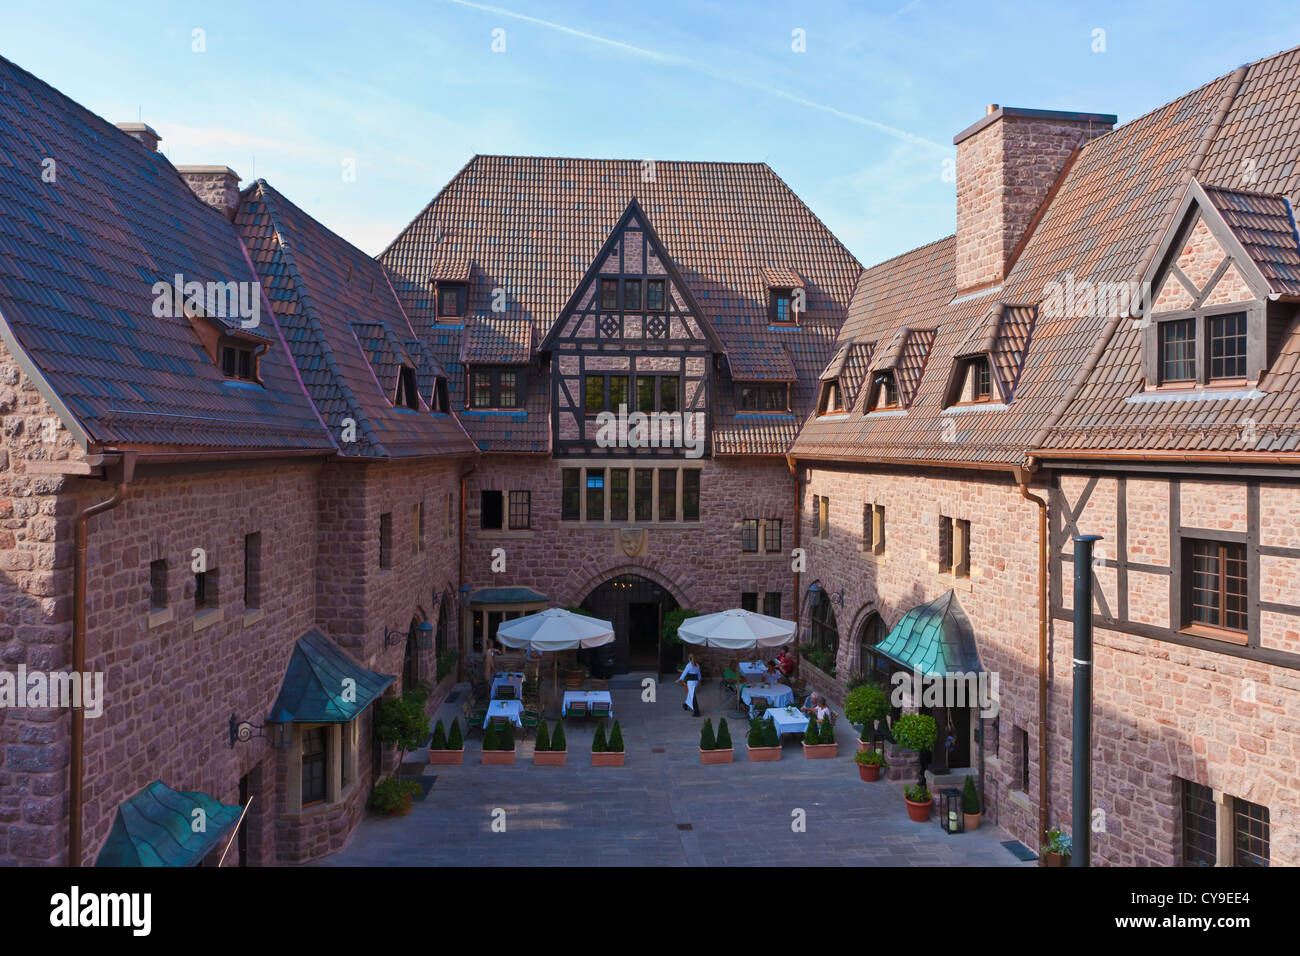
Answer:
235;179;475;458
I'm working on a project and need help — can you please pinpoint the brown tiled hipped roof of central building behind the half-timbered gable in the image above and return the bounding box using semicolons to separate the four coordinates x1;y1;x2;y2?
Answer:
380;156;861;454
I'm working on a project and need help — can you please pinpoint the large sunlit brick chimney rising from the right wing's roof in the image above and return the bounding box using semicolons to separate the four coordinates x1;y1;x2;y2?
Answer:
953;104;1117;293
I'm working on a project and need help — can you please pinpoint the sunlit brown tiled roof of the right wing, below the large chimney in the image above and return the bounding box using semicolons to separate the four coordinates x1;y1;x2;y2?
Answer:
793;49;1300;466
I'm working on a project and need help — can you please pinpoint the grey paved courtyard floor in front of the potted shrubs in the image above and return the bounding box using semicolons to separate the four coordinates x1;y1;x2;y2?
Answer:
321;676;1034;866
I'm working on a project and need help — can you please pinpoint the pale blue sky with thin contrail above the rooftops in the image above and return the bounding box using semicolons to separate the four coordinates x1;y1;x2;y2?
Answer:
0;0;1300;265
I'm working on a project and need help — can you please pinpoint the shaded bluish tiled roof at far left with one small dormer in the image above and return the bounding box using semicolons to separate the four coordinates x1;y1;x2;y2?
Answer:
0;59;333;451
